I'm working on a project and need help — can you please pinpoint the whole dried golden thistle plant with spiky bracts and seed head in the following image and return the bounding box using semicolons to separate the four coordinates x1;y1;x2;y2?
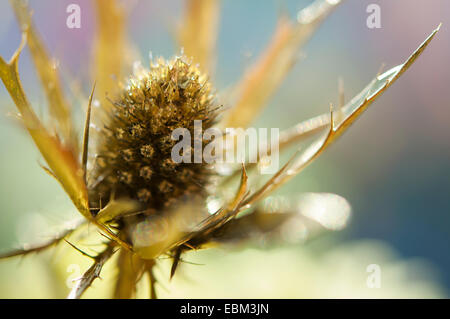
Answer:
0;0;437;298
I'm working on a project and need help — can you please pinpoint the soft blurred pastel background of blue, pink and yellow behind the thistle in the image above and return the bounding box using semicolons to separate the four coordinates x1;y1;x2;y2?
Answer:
0;0;450;298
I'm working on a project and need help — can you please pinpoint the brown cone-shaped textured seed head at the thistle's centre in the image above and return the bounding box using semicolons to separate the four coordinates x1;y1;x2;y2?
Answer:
89;57;217;211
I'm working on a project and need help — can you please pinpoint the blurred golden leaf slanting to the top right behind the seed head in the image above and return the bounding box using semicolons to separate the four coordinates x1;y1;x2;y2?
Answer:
223;0;341;127
